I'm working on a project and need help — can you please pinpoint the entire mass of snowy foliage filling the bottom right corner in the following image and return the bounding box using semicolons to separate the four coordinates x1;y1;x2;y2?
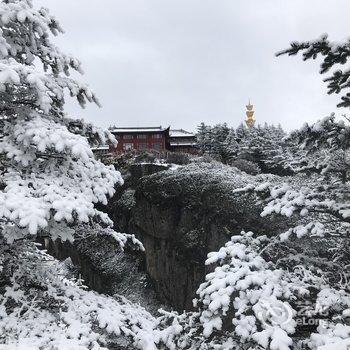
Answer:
155;232;350;350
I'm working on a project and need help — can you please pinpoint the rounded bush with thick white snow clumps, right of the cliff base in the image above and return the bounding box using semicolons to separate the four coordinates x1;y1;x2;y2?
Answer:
195;232;309;350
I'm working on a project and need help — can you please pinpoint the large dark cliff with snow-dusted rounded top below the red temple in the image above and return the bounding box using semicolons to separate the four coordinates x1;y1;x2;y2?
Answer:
109;163;284;311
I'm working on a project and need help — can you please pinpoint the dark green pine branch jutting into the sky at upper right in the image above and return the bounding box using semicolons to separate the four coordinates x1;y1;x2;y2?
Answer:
276;34;350;107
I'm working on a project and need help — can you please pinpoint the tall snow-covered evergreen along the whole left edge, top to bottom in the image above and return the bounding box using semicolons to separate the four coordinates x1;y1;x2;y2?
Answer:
0;0;164;350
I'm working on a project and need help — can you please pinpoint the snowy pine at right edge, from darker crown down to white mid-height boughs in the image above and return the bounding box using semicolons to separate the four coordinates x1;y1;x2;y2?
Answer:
245;115;350;238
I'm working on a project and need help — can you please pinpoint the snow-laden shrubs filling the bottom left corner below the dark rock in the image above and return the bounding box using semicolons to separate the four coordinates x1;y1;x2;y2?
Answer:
0;241;156;350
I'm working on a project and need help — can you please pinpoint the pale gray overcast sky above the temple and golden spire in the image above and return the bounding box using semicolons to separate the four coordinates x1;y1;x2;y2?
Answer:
34;0;350;130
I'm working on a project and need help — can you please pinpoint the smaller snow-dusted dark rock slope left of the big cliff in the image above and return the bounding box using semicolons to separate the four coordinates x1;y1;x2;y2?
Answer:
41;228;164;315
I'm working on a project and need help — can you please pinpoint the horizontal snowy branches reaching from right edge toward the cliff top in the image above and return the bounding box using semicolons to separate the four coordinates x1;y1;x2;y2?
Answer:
237;176;350;240
